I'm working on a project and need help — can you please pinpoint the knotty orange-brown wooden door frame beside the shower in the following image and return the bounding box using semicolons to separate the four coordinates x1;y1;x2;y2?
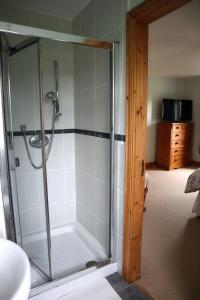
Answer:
123;0;192;282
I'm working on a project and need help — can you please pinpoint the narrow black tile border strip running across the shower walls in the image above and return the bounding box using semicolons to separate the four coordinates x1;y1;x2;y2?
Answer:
11;128;125;142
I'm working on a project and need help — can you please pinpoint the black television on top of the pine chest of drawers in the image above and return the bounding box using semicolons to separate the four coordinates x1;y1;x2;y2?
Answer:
162;98;192;122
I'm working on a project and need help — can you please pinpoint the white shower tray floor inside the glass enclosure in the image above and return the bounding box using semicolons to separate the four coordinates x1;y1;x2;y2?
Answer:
26;225;105;288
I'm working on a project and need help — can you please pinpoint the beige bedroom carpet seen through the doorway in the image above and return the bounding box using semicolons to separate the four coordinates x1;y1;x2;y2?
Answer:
138;168;200;300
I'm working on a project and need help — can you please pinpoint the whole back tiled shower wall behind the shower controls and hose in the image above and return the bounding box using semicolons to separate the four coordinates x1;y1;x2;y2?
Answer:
10;35;76;236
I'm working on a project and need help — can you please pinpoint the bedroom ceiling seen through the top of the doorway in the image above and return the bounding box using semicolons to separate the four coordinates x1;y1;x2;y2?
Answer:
149;0;200;77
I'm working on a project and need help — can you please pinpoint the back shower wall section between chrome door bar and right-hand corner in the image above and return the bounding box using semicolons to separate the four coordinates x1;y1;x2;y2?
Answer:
43;40;76;231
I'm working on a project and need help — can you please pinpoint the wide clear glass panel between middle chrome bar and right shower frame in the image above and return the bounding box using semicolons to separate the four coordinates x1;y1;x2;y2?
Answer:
41;39;110;278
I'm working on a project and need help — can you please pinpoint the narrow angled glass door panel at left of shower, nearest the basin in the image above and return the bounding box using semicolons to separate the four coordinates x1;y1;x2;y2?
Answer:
5;36;50;276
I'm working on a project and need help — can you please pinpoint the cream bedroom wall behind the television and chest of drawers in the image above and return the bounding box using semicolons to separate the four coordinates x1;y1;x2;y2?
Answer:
146;75;200;162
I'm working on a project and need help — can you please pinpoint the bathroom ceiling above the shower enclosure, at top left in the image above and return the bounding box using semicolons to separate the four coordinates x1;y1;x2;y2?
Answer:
0;0;90;20
